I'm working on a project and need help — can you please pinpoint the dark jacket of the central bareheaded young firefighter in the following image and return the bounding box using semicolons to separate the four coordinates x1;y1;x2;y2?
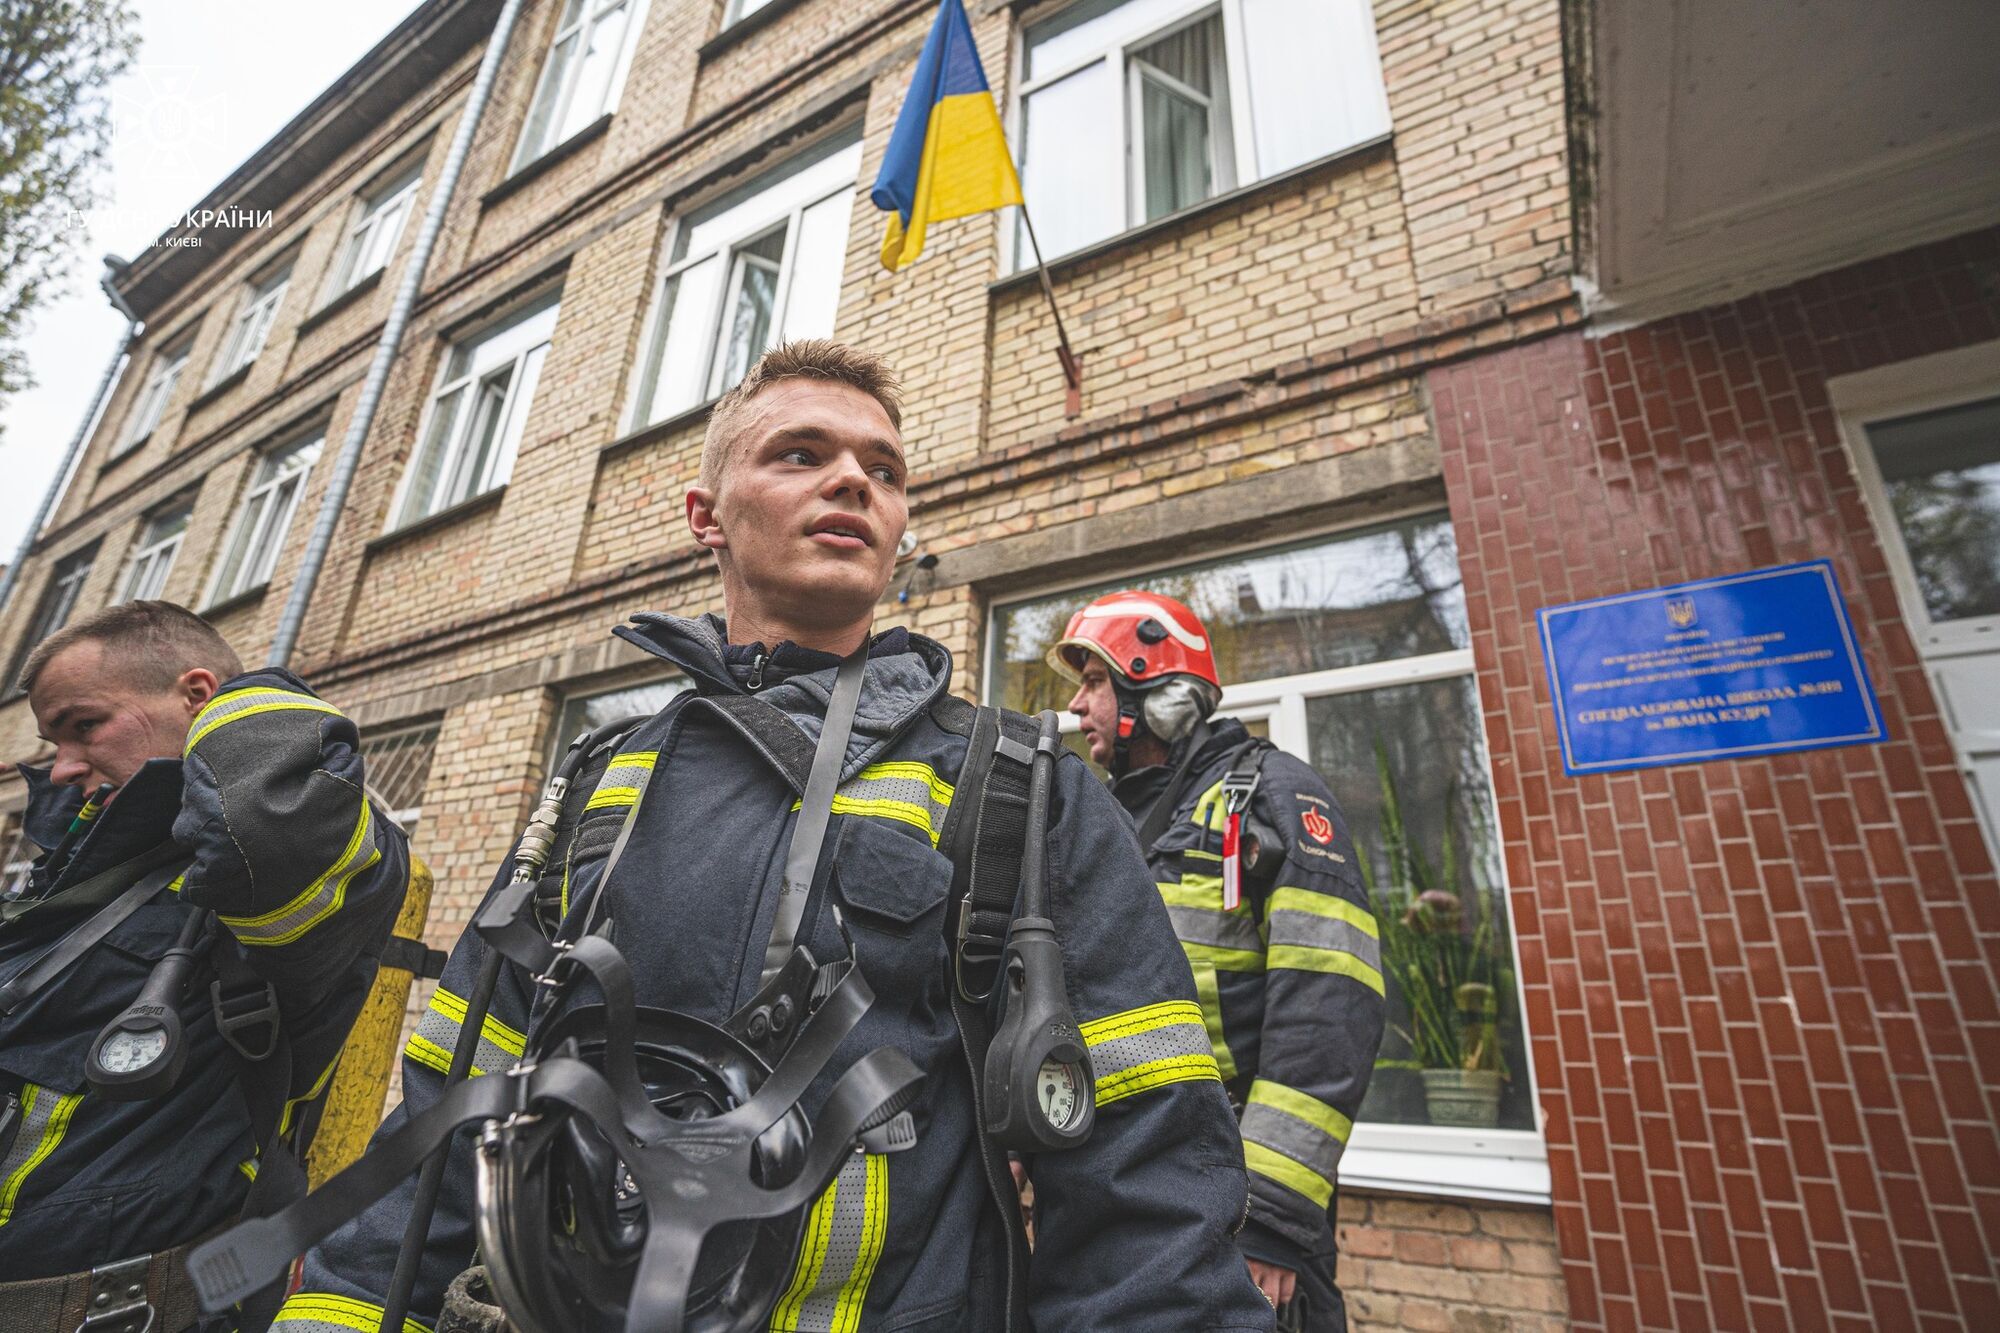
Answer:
290;614;1272;1333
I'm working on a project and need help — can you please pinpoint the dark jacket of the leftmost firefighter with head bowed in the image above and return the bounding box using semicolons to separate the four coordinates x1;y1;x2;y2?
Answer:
0;669;410;1279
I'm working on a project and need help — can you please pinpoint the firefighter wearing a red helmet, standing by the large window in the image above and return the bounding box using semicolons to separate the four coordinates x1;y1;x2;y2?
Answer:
1048;590;1382;1333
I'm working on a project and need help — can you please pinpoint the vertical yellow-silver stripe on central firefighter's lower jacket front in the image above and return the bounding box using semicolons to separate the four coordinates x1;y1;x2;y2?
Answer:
770;1153;888;1333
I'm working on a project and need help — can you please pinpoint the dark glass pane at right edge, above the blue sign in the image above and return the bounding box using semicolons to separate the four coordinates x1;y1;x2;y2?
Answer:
1868;398;2000;620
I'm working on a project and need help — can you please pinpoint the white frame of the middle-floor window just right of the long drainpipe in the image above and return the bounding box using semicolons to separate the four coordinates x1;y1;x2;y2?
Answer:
382;288;562;532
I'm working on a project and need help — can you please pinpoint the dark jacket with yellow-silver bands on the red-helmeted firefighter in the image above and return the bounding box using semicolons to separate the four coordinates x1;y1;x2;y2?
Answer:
1114;721;1384;1271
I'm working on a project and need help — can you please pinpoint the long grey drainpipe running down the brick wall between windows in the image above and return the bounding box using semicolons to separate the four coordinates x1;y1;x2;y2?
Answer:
270;0;522;667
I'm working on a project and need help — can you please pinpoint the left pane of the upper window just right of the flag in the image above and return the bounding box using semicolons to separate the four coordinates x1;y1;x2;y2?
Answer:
1016;60;1126;264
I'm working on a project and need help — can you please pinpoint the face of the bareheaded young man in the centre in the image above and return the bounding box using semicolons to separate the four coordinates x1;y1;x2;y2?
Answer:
688;380;910;630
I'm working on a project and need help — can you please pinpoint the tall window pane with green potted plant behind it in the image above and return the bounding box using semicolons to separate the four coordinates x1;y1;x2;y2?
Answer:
1306;677;1534;1129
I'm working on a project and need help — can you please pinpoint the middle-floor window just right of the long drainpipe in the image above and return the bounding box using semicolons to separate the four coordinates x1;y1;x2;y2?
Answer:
390;292;560;528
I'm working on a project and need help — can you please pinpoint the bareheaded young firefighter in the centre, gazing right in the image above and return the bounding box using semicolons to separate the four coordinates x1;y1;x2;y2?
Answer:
278;340;1272;1333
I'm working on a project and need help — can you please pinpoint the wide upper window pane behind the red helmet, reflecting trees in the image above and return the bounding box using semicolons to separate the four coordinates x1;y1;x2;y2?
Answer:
992;514;1470;713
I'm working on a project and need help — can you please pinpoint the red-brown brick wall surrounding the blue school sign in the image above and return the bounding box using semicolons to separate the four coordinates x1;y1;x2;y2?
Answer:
1428;230;2000;1329
